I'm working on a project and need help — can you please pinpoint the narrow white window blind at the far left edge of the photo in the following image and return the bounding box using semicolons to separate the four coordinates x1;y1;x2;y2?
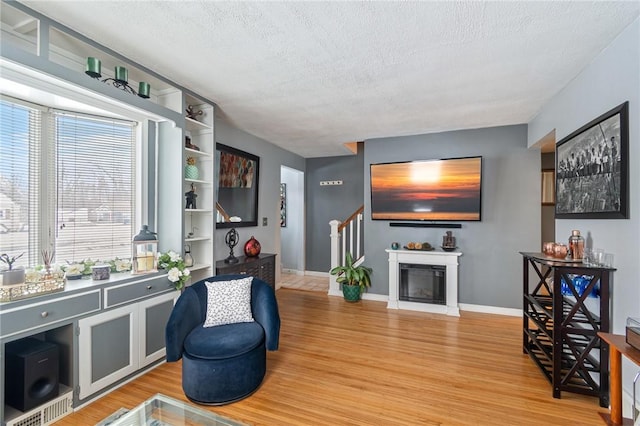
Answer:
0;98;42;267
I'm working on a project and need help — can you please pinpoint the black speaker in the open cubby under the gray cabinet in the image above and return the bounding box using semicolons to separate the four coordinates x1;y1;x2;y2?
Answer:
4;337;59;411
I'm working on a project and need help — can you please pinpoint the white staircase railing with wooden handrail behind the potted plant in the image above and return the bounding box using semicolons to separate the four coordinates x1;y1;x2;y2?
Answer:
329;205;364;296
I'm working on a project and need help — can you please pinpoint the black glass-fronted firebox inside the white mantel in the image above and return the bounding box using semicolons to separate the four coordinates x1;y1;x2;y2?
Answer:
398;263;447;305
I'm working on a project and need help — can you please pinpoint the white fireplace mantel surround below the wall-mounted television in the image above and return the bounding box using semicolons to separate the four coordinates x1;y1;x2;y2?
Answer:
386;249;462;317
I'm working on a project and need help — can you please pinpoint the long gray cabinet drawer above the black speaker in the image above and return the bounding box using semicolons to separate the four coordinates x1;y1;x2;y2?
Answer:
0;290;100;337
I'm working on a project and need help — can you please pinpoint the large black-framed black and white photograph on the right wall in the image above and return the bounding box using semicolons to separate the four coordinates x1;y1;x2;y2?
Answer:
556;102;629;219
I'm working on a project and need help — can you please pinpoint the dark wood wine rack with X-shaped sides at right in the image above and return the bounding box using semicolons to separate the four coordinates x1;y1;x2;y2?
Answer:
520;252;615;408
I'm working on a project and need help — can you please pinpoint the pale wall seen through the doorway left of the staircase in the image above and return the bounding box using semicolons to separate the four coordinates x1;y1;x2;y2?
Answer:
280;166;305;272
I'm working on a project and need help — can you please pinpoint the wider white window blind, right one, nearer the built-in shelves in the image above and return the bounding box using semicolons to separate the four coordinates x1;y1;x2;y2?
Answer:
52;111;136;263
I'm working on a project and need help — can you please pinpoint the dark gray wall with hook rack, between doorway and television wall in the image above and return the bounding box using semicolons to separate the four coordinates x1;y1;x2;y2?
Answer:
305;143;364;272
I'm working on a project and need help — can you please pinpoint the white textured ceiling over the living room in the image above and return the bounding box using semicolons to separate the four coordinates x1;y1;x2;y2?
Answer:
23;0;640;157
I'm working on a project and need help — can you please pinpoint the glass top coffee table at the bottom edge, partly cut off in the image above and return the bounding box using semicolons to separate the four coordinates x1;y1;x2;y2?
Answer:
104;393;244;426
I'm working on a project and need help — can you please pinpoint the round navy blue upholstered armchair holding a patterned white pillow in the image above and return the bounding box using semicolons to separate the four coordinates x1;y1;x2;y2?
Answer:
166;275;280;405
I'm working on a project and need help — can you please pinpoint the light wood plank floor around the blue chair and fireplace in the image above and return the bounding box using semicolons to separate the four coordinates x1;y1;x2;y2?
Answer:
57;288;606;426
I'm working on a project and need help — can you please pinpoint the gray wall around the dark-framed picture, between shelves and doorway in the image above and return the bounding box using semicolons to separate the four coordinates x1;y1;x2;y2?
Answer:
215;116;305;282
